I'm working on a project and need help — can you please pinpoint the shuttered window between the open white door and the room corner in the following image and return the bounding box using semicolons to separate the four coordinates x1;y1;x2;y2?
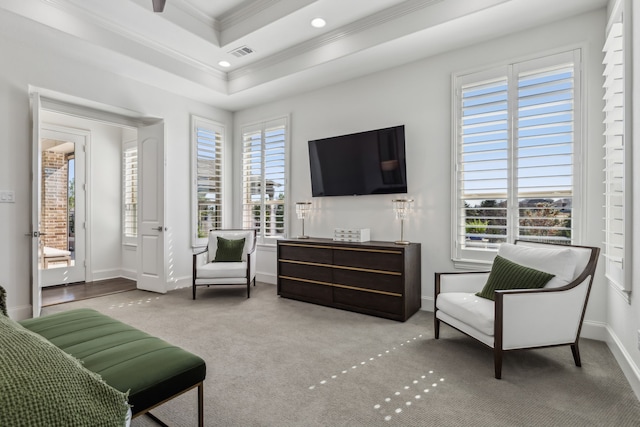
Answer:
191;116;224;246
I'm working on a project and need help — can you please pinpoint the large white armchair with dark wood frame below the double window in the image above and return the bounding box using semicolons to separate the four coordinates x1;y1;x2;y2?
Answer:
434;241;600;379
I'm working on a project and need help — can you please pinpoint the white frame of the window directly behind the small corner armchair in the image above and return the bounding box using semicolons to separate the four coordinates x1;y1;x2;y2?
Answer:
191;114;227;248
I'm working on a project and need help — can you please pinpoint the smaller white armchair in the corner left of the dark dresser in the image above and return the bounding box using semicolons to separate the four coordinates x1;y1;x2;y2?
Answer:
193;230;256;299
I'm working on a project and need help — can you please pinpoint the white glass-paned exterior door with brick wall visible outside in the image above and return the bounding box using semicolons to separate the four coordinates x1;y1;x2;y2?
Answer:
39;124;89;287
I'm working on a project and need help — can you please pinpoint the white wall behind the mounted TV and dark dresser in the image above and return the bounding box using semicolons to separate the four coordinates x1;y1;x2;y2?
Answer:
234;10;606;328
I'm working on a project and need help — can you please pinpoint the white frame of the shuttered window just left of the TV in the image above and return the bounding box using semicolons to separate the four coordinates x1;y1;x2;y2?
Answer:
240;115;291;246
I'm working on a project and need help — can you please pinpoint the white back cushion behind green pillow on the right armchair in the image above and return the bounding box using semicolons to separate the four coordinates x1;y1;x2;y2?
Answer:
498;241;590;288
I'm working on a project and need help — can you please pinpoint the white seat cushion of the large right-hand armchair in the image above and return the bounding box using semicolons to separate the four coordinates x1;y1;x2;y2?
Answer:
436;292;495;336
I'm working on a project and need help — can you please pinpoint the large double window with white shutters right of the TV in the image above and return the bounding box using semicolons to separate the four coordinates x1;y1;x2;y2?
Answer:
453;50;581;262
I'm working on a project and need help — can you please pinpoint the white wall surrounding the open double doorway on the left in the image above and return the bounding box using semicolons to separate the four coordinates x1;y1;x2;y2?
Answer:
0;26;232;318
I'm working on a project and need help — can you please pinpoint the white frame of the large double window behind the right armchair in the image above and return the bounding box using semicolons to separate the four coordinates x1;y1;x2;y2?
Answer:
451;47;585;269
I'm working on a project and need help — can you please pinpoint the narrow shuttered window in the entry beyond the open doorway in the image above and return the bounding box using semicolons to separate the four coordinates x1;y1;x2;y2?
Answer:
122;141;138;245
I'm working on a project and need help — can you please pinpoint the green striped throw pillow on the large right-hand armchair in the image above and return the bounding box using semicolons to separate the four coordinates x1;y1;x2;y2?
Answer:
476;255;555;300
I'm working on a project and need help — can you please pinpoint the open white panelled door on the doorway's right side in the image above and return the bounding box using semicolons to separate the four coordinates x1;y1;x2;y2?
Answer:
137;121;167;293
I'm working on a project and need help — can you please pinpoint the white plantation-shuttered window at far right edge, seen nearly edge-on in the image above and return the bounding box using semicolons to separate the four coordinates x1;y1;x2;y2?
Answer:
603;9;632;293
